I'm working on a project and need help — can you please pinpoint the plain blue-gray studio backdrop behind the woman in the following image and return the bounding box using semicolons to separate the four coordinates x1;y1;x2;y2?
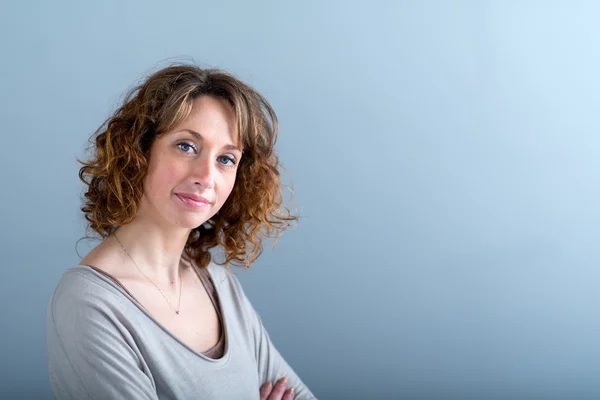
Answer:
0;0;600;399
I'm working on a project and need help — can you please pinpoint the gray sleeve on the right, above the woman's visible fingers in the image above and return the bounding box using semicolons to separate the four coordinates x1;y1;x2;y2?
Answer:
231;274;316;400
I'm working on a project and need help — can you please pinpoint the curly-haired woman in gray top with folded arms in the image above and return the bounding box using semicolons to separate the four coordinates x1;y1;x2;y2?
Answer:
47;65;314;400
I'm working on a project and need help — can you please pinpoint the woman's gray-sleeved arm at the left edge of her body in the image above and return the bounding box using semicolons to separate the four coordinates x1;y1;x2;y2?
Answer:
46;282;158;400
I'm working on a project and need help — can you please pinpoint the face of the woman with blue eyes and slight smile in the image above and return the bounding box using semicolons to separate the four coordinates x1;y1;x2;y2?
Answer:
138;96;242;229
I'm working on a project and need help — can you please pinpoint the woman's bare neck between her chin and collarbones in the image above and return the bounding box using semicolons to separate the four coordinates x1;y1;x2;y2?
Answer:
110;215;191;283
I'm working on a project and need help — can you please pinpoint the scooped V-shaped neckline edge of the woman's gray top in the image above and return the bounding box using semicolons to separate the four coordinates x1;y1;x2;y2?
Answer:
75;264;230;364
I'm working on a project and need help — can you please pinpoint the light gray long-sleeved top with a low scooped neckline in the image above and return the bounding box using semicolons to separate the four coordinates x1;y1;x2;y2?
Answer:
46;264;315;400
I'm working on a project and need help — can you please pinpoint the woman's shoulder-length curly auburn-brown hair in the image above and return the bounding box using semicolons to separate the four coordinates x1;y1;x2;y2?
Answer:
78;64;297;268
